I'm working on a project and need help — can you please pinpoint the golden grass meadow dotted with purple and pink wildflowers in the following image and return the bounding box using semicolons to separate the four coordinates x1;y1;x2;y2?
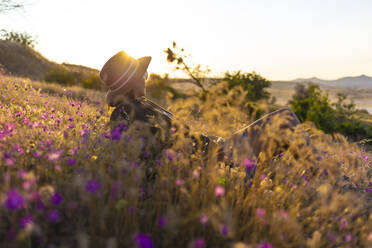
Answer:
0;76;372;248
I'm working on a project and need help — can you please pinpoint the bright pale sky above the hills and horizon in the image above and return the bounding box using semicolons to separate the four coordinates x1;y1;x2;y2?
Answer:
0;0;372;80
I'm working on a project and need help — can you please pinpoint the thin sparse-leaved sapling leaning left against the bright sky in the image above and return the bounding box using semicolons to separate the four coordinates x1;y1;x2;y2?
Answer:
164;41;211;93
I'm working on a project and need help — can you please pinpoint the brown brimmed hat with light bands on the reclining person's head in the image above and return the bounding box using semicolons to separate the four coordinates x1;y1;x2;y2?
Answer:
100;51;151;106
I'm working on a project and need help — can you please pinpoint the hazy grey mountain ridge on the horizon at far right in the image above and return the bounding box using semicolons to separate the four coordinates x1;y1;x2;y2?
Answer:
292;75;372;88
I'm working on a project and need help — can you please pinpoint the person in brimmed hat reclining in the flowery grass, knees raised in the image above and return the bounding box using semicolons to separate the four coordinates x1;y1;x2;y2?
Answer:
100;51;309;176
